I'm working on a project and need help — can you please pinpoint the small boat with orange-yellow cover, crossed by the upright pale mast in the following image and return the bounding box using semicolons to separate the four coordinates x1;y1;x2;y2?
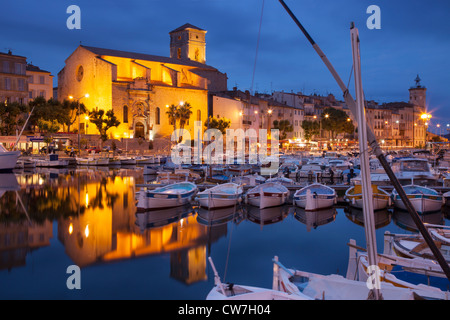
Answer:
344;184;391;210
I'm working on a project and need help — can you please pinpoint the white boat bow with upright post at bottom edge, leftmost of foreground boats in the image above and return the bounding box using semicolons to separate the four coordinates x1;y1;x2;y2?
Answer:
206;257;312;302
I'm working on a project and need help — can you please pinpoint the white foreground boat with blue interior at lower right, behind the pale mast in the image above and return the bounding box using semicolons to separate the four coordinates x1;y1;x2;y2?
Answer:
346;239;450;300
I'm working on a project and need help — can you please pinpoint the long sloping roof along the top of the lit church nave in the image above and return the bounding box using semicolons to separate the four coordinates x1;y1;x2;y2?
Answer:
80;45;217;70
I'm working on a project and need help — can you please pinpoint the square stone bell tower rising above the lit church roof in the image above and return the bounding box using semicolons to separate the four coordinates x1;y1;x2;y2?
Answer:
169;23;206;63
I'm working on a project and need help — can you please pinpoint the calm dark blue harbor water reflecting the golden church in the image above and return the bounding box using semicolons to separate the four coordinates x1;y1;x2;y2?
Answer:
0;167;450;300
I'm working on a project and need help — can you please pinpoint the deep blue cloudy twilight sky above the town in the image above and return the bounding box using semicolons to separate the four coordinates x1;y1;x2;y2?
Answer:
0;0;450;131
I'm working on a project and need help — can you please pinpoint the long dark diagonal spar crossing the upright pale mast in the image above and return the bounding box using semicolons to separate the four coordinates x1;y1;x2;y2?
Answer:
278;0;450;281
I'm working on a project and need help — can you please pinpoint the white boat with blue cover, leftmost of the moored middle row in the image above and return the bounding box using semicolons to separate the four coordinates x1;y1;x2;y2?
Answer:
137;182;198;211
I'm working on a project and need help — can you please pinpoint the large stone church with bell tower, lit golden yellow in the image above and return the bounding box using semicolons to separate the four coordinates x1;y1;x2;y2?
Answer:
58;24;227;140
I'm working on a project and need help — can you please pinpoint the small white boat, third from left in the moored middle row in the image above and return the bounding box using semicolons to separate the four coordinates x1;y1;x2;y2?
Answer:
245;182;289;209
